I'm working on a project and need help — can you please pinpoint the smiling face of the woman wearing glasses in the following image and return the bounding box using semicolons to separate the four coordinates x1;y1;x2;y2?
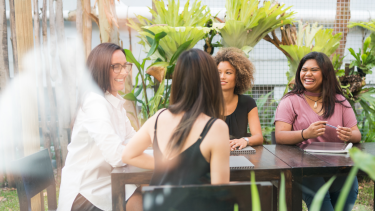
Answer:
108;50;128;96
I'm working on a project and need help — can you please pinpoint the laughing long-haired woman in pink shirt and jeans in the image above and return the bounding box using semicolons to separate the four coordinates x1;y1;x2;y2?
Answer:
275;52;361;211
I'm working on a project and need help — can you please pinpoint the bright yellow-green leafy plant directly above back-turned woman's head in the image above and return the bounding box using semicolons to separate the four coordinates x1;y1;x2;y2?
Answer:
128;0;211;61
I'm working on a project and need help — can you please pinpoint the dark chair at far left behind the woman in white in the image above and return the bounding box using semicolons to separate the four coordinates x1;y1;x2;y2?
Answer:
12;149;57;211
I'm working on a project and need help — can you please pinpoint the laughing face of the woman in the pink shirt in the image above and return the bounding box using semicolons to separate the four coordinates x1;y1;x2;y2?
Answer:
300;59;323;93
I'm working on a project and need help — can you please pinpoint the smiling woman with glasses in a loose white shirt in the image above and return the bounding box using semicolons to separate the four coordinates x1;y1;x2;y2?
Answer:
58;43;141;211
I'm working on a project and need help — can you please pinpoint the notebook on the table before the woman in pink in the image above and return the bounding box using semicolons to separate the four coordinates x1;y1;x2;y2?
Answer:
300;142;353;153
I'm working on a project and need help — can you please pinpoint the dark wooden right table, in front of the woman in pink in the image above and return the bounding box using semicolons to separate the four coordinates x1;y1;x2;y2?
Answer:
264;143;375;211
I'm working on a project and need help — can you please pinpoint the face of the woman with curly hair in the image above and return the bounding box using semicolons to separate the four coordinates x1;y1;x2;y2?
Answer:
217;61;236;92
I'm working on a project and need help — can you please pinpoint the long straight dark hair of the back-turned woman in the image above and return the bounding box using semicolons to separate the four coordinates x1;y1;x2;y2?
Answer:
167;49;224;157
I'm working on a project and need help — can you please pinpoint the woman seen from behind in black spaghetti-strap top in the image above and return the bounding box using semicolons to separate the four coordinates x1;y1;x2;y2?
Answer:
122;49;230;185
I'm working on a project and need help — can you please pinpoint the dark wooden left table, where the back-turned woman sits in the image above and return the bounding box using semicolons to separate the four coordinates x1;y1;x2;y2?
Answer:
111;146;293;211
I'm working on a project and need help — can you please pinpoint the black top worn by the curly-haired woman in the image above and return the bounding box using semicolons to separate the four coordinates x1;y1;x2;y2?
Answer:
225;95;257;139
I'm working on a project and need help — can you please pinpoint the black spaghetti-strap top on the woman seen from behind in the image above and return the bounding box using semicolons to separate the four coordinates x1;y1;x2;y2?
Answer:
150;110;216;185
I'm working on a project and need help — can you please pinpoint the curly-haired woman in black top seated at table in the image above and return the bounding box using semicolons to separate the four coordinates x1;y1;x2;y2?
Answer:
215;48;263;151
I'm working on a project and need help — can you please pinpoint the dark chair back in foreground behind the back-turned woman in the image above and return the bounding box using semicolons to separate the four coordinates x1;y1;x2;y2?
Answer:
142;182;273;211
